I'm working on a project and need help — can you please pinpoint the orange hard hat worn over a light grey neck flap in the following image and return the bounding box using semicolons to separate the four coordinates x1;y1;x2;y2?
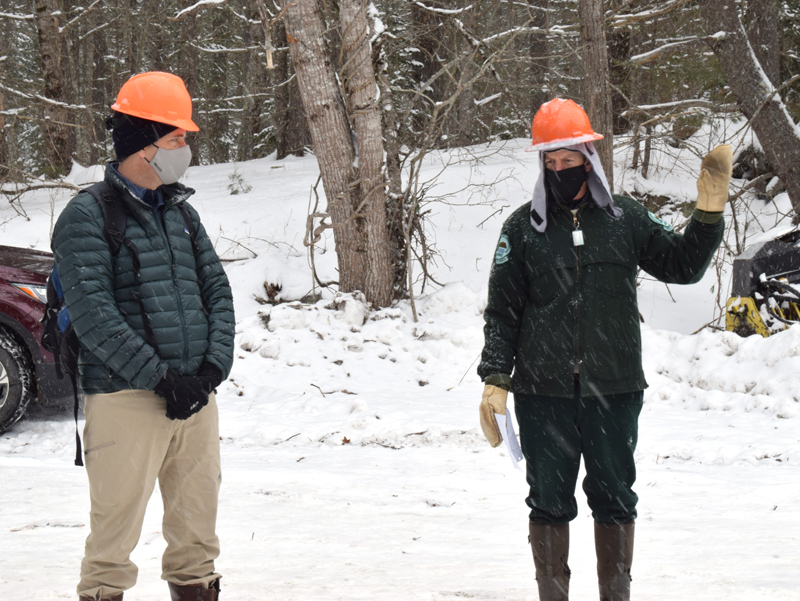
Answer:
528;98;603;151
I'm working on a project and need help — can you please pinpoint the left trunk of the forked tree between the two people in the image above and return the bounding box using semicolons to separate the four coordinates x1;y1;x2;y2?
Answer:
283;0;367;292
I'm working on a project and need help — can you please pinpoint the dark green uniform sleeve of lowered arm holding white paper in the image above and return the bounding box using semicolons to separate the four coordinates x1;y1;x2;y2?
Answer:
478;222;528;389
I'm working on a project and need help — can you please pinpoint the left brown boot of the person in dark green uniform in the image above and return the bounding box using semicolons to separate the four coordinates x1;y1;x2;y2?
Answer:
528;522;570;601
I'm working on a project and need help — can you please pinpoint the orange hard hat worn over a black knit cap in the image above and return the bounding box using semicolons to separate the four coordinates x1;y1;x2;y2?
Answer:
111;71;200;131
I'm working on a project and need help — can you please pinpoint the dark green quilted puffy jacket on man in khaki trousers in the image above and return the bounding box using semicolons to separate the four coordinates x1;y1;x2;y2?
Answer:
52;168;234;394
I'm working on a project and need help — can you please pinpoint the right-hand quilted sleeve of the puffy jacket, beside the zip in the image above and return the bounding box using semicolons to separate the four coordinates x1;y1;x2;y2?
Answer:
187;203;236;378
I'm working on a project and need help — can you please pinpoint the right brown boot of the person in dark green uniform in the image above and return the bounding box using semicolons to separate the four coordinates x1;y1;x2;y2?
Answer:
594;522;634;601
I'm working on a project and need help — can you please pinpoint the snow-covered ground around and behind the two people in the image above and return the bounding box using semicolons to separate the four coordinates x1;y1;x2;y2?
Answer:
0;141;800;601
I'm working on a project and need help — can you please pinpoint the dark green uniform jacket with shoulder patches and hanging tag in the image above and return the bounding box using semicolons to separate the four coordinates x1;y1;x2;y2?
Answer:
478;196;724;397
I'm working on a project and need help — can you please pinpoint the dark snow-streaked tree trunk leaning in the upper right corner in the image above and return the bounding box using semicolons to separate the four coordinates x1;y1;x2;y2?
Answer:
700;0;800;217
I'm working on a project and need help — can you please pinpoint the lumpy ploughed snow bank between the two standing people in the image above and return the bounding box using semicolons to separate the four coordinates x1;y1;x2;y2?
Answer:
221;285;483;448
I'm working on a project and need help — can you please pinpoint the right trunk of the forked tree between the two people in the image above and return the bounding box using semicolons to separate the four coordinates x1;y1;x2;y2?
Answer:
339;0;392;307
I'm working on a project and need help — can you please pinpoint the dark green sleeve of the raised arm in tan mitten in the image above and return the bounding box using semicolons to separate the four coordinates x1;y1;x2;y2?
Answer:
634;206;725;284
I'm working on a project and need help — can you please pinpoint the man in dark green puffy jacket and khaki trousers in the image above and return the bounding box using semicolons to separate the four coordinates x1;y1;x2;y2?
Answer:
52;73;234;601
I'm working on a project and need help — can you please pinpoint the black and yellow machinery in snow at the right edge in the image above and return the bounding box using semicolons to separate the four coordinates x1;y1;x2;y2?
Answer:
725;231;800;337
